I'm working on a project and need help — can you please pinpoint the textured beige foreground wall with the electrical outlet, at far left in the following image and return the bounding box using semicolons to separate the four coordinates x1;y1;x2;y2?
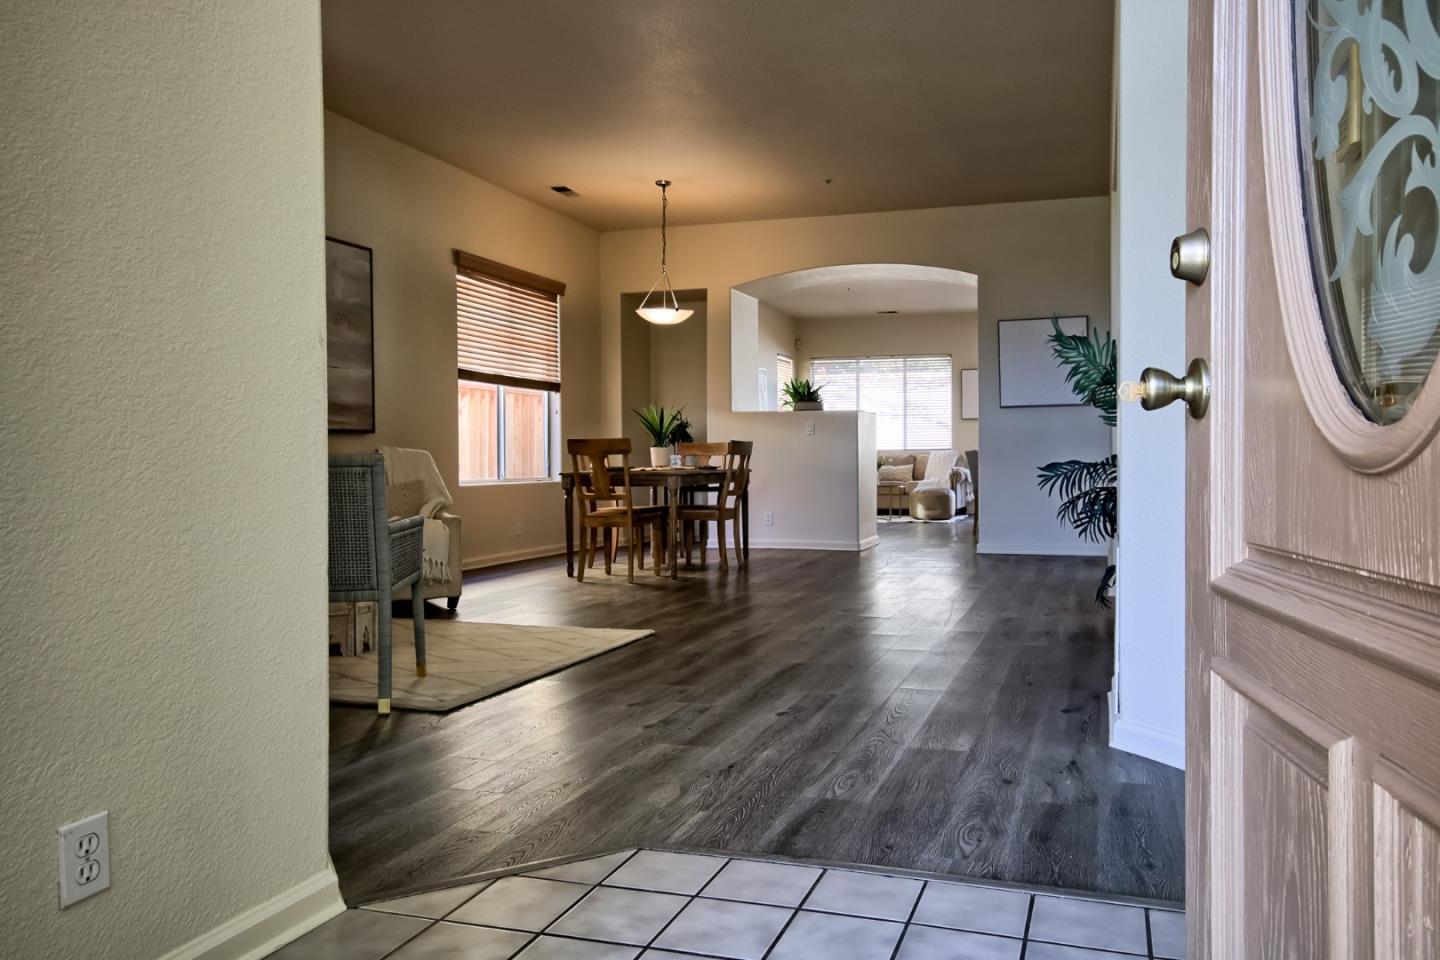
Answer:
0;0;330;960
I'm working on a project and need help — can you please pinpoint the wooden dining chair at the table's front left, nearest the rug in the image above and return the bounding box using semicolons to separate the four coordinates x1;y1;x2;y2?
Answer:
566;436;670;583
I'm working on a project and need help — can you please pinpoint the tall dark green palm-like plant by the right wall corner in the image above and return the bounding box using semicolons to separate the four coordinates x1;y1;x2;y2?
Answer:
1038;317;1117;607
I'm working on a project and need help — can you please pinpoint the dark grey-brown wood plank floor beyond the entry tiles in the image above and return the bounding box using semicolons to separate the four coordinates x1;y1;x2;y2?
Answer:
330;524;1184;901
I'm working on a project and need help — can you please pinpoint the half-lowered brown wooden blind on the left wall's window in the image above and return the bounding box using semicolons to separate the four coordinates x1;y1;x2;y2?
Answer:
455;250;564;391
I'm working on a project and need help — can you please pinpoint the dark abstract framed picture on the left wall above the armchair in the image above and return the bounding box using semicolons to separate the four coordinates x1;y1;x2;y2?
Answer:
325;236;374;433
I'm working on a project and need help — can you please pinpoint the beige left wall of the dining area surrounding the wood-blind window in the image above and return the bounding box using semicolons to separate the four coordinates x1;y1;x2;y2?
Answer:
325;112;599;566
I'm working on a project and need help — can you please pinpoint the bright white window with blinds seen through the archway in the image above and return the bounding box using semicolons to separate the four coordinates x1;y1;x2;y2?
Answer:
811;357;955;450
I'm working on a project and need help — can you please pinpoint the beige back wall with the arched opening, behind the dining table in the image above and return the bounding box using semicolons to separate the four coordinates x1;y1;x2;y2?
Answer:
600;197;1110;553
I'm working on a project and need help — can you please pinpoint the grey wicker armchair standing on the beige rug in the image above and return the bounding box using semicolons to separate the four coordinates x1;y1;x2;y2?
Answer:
330;453;425;715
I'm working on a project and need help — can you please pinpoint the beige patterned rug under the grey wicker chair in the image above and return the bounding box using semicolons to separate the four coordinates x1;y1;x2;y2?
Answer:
330;617;654;712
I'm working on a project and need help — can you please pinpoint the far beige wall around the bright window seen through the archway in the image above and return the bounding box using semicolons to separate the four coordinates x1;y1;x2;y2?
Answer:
796;312;994;452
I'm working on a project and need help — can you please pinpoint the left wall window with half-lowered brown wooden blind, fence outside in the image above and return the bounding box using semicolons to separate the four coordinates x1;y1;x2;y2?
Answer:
455;250;564;484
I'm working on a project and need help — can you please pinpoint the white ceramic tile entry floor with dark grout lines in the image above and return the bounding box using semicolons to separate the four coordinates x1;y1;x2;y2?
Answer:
271;851;1185;960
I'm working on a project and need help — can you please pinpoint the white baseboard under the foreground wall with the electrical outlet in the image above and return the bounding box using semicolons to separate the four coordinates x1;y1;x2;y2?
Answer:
160;866;346;960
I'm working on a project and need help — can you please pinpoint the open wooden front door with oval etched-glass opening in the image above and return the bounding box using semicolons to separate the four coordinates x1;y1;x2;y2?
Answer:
1187;0;1440;960
